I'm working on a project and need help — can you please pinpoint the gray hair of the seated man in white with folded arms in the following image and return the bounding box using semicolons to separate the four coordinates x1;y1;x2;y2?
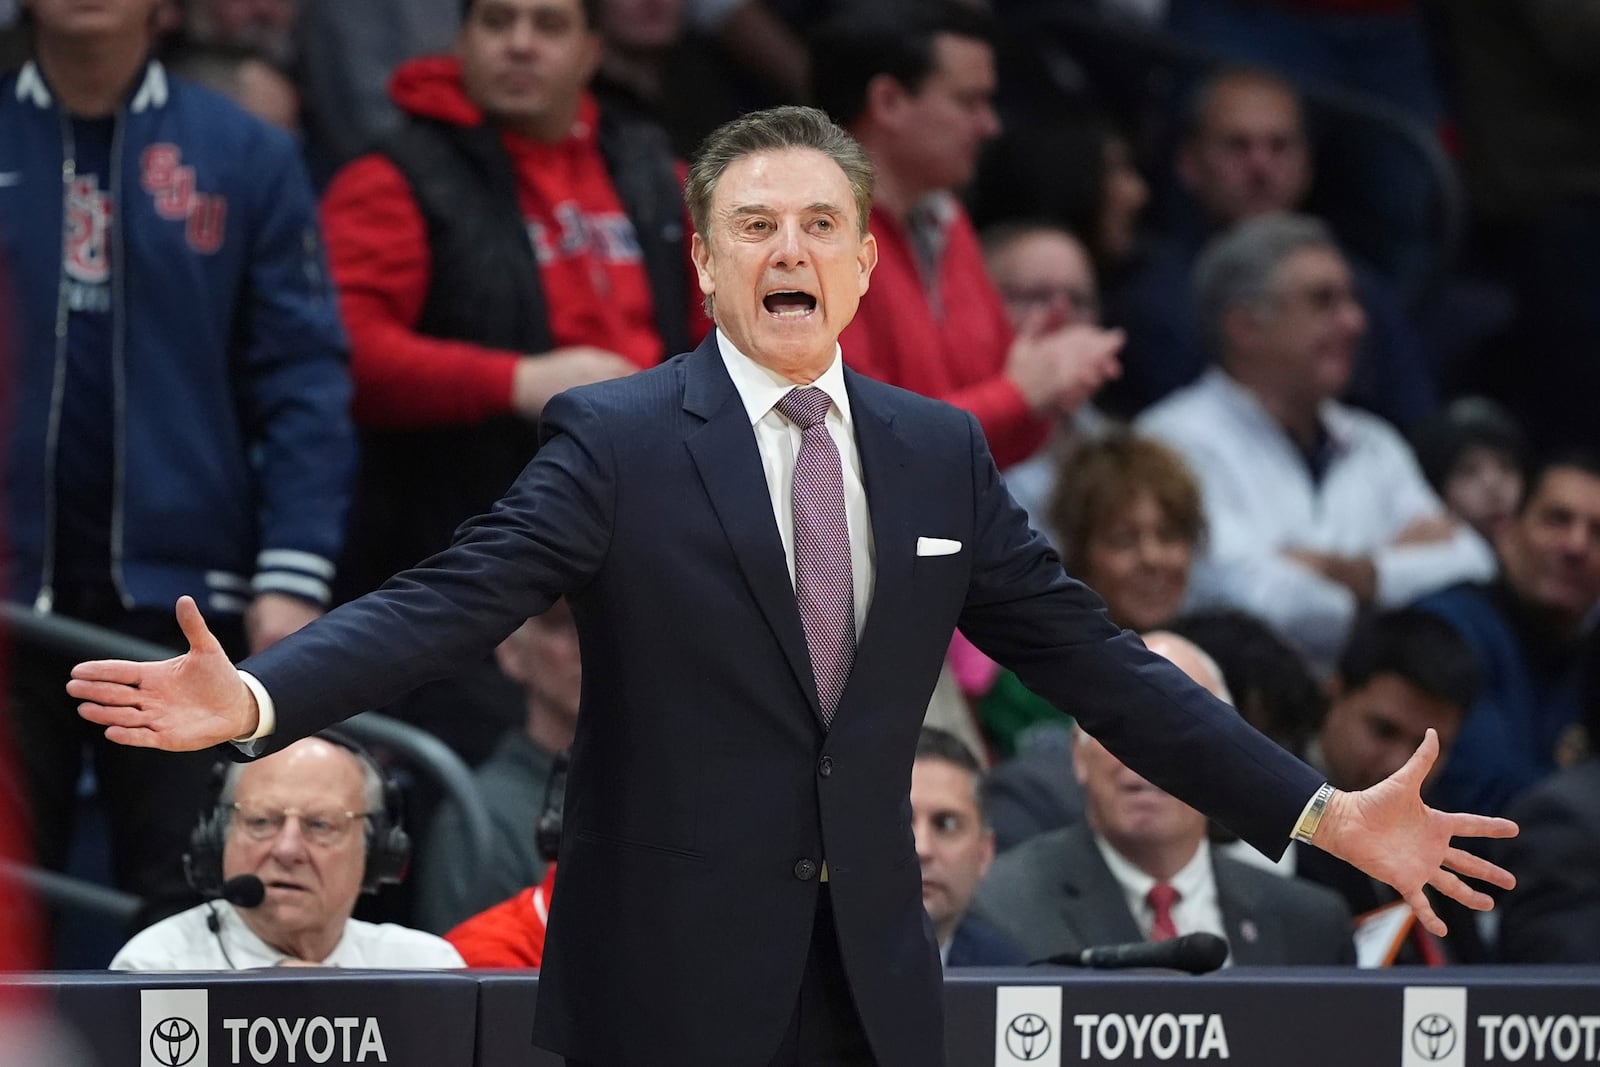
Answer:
1194;213;1339;357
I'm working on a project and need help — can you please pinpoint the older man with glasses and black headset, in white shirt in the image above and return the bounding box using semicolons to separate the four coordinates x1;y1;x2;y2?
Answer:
110;733;464;971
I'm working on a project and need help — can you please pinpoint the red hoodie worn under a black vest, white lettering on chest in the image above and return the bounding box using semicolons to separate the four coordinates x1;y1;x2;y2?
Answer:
322;56;698;427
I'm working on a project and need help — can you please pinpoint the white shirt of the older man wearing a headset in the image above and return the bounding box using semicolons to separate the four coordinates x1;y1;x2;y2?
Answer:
110;901;466;971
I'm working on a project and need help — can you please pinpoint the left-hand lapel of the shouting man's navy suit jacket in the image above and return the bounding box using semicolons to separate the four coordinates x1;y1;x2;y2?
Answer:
683;340;821;715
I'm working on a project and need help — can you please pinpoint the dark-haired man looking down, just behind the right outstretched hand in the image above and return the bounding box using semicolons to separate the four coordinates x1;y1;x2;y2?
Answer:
1293;608;1478;965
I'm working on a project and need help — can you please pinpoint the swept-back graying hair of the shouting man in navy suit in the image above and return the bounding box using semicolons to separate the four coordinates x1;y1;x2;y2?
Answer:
683;106;872;237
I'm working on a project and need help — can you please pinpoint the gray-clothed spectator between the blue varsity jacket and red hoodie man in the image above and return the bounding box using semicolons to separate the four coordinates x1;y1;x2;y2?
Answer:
294;0;460;184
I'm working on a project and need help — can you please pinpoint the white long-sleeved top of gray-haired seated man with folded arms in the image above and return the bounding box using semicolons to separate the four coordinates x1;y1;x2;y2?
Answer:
1136;368;1494;667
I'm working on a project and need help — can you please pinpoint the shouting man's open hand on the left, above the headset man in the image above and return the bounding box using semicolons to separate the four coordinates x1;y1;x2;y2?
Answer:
67;597;259;752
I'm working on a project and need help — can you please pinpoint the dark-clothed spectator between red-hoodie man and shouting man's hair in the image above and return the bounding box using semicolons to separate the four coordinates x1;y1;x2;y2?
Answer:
594;0;739;158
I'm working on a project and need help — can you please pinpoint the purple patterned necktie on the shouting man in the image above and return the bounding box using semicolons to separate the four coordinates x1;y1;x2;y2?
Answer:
776;386;856;726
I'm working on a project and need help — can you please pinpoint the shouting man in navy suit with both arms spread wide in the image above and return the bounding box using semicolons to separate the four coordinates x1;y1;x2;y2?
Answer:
67;107;1515;1067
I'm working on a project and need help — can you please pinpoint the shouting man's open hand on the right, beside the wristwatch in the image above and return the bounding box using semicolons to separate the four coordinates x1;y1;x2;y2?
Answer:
1312;729;1517;936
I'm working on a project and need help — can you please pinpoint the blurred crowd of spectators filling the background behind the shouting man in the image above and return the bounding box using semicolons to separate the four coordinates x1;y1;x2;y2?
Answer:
0;0;1600;985
